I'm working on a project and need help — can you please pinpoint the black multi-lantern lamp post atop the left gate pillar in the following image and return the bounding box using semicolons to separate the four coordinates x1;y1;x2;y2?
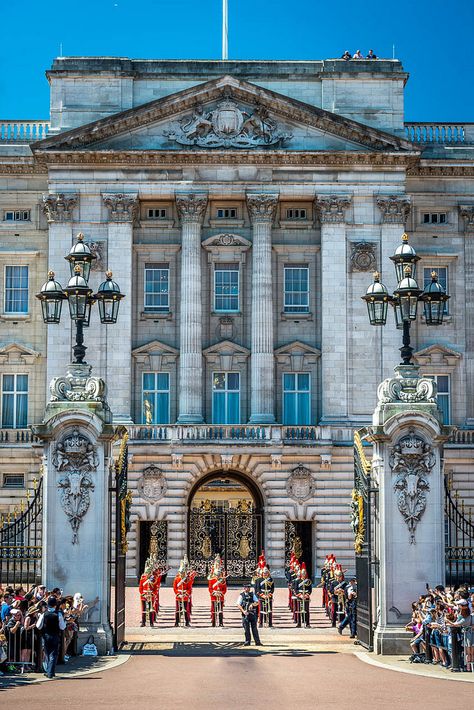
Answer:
36;234;124;365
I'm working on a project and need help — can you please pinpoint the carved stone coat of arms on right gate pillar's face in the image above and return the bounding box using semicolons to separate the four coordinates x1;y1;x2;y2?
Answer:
389;429;436;544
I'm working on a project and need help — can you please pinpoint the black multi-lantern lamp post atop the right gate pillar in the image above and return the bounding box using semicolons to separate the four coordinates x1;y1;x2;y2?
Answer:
362;234;449;365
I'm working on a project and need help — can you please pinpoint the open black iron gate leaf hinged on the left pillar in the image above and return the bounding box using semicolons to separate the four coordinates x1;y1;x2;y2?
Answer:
111;434;132;648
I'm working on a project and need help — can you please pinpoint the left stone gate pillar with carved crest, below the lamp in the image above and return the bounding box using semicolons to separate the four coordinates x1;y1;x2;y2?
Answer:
34;364;114;653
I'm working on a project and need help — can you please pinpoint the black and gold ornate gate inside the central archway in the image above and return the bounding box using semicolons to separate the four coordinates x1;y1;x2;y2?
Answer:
188;506;262;580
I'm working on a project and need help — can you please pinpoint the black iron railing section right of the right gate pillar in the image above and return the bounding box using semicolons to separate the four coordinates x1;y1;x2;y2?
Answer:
444;478;474;587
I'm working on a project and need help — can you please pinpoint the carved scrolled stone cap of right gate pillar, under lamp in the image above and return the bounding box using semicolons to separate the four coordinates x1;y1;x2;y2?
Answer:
377;365;436;405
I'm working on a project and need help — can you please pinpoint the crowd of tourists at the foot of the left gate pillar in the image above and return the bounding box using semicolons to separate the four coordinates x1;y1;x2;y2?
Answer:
0;584;96;675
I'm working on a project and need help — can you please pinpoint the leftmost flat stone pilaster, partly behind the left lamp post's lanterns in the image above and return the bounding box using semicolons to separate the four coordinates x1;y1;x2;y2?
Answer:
43;193;79;390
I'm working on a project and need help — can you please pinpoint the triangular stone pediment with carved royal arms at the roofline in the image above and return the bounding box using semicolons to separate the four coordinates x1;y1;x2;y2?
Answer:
32;76;413;154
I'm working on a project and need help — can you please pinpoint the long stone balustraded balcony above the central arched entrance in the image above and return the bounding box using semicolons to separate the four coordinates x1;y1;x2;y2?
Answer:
127;424;354;446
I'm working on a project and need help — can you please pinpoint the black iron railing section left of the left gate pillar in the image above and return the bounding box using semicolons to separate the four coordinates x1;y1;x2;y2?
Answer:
0;478;43;587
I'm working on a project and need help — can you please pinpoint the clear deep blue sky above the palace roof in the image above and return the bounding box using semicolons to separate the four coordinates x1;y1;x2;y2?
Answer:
0;0;474;121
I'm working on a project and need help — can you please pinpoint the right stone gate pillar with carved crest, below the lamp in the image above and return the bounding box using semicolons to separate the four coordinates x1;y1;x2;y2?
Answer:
369;365;449;655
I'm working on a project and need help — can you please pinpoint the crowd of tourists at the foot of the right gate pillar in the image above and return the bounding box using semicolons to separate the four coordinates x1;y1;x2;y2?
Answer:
406;584;474;672
